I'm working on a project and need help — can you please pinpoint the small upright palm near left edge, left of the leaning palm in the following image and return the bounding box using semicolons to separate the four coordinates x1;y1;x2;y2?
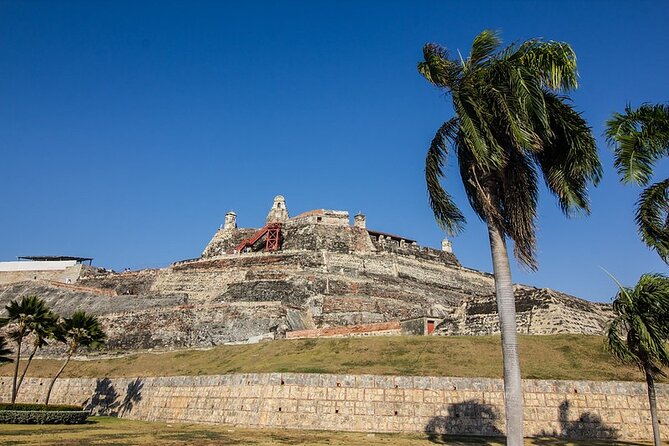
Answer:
3;296;53;404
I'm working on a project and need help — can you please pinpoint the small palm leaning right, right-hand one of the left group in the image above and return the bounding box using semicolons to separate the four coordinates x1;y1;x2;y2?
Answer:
45;311;107;404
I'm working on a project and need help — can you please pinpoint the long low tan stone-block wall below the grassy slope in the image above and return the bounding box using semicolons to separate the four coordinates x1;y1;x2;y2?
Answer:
0;373;669;440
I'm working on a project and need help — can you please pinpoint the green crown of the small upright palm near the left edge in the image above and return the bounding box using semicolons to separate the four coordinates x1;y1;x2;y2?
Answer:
3;296;57;342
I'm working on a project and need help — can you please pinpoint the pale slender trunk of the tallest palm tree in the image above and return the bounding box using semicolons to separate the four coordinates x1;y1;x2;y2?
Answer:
488;223;523;446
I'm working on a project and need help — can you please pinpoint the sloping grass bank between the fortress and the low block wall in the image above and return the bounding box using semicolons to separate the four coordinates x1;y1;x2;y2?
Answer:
0;335;656;381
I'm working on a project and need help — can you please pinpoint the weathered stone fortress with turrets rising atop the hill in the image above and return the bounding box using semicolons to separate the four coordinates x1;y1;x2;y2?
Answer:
0;195;611;350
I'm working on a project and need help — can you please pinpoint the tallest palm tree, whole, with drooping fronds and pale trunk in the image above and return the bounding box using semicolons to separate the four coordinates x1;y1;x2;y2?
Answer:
418;31;601;445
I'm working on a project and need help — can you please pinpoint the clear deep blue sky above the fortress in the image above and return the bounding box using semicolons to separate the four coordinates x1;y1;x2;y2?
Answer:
0;0;669;301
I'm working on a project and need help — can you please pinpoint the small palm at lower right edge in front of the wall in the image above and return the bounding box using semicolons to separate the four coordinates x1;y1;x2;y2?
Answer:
605;274;669;446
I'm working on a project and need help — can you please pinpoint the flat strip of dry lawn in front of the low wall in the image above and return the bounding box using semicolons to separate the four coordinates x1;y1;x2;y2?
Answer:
0;417;650;446
